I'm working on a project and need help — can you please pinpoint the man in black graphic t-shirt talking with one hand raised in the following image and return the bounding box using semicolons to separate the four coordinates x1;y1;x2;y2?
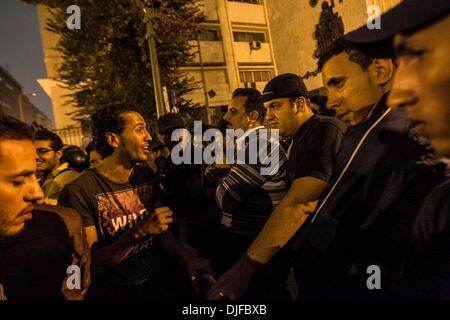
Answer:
60;105;209;299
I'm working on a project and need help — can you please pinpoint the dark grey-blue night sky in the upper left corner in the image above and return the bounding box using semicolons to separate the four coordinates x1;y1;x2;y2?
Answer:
0;0;53;121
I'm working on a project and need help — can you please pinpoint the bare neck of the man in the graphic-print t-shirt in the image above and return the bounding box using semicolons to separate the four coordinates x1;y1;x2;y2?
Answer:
97;152;133;183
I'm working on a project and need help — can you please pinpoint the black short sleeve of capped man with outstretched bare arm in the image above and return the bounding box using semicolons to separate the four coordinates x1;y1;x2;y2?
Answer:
293;122;344;183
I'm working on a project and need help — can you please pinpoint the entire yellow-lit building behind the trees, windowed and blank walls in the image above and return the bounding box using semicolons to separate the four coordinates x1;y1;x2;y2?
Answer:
38;0;400;132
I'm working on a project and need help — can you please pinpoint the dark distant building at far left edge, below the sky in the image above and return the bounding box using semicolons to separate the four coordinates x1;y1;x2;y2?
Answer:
0;66;53;129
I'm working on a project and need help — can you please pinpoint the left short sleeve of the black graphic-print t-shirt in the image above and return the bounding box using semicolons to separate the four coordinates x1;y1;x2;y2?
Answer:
58;184;95;227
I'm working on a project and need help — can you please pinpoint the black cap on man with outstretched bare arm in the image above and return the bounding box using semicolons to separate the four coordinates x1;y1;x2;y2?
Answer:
262;73;309;102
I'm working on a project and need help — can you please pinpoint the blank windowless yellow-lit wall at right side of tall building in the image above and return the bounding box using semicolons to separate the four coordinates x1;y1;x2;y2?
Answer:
265;0;400;90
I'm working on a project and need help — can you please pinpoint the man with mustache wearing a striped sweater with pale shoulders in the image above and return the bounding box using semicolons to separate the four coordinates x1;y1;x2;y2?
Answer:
216;88;290;300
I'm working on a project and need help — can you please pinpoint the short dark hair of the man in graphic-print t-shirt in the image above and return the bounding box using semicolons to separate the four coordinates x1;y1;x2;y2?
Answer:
91;104;139;158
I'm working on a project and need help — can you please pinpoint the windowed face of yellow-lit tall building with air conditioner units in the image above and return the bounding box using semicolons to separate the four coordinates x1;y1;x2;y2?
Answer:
182;0;277;123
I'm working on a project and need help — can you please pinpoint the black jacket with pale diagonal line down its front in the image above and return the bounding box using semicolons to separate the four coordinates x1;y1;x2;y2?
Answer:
292;97;445;298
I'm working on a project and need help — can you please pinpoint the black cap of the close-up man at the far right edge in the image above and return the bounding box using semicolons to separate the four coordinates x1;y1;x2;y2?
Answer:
344;0;450;44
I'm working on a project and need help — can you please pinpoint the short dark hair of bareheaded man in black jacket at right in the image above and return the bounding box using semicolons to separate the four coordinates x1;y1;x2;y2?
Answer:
317;39;375;70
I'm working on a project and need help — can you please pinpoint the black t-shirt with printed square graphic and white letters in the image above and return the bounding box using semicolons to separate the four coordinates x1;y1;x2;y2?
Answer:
59;166;158;286
